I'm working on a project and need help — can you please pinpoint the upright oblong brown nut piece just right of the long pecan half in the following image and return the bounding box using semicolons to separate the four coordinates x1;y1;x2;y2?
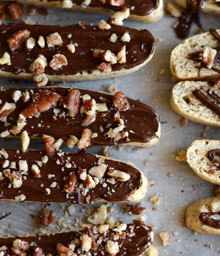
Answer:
66;89;80;117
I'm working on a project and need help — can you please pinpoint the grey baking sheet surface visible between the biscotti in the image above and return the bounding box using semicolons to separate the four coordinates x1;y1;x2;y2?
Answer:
0;3;220;256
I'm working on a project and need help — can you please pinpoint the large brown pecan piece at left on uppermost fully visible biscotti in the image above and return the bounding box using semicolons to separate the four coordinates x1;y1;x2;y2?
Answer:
8;29;31;51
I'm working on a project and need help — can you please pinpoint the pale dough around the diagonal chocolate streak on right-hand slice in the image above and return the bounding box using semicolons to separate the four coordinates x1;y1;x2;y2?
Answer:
170;81;220;127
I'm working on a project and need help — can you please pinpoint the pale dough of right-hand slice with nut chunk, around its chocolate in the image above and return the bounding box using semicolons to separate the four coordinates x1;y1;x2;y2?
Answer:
170;29;220;80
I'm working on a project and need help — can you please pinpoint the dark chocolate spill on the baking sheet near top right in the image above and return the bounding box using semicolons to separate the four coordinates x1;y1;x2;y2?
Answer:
174;0;204;39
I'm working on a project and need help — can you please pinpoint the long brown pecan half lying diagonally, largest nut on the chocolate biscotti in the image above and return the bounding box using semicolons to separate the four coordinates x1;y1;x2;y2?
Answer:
21;91;61;117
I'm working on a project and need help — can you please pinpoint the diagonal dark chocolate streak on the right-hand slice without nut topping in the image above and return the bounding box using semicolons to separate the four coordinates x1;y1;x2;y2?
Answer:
193;89;220;116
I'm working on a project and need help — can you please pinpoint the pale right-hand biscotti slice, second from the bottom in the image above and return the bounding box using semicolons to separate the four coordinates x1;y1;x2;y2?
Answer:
186;140;220;185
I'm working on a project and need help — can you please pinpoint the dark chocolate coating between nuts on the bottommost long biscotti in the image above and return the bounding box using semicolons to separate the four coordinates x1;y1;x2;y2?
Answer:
0;221;152;256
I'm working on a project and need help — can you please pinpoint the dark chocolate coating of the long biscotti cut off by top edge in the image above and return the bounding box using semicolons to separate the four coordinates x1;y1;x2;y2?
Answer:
42;0;159;16
